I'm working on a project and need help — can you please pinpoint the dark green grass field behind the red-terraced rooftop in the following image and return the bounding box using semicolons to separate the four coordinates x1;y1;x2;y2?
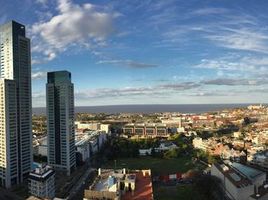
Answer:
102;156;201;175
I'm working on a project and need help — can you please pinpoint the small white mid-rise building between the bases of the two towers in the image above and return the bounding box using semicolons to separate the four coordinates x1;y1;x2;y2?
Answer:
28;166;55;199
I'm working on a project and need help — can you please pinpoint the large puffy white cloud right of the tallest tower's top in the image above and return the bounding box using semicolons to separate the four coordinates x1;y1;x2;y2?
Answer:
31;0;119;60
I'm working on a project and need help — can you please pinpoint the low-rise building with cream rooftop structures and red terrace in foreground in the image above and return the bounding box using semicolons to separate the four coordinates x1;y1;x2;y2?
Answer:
84;169;153;200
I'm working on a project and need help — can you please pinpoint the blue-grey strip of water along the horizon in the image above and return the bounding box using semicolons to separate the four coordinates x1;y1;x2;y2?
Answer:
33;104;258;115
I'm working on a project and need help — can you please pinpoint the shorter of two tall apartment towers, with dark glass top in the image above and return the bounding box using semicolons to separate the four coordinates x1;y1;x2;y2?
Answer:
46;71;76;175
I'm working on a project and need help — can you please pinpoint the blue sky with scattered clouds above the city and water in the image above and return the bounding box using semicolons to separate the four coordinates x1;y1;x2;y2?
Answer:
0;0;268;107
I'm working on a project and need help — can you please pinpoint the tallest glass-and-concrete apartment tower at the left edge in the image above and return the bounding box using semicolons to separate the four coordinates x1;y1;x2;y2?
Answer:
0;21;33;188
